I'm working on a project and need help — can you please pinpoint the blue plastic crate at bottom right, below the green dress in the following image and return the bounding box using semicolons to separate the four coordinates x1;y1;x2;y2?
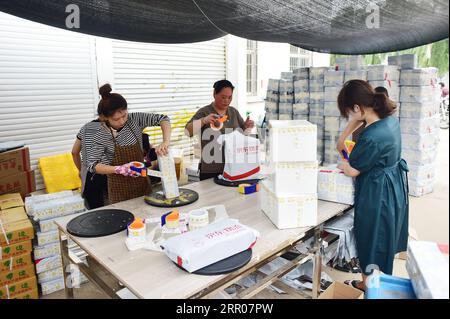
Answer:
365;274;417;299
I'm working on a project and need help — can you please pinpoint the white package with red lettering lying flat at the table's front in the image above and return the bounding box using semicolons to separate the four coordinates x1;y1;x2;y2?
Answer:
161;218;259;272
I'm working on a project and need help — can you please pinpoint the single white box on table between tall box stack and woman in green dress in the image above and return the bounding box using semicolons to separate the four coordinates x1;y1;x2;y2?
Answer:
317;165;355;205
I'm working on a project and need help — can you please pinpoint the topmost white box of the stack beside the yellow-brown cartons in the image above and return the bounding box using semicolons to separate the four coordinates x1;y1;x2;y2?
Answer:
32;194;86;221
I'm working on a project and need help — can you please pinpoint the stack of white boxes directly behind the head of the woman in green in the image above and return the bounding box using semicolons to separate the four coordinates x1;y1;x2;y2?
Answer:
367;65;400;117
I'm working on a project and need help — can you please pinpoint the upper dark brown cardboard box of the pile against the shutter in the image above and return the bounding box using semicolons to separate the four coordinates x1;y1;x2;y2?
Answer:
0;147;30;178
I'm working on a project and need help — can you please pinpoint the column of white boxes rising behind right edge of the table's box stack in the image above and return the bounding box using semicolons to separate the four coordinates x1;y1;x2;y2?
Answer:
308;67;329;164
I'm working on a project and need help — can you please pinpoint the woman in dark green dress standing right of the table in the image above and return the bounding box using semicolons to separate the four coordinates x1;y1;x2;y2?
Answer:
338;80;408;290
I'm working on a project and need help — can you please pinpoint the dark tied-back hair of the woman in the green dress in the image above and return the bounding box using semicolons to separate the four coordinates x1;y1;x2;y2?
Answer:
338;80;397;119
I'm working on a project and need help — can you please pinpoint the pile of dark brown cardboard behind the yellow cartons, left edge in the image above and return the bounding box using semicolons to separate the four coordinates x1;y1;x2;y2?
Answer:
0;147;36;198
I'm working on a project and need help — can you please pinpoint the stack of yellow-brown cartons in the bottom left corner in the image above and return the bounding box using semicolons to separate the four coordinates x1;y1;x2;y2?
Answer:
0;193;38;299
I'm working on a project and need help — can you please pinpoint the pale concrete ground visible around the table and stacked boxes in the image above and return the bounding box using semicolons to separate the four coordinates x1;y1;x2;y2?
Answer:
42;129;449;299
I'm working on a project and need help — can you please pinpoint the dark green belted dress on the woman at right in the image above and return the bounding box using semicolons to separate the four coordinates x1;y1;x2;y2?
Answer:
349;116;409;274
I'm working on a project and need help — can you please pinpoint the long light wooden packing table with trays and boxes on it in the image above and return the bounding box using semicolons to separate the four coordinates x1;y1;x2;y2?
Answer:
56;179;350;298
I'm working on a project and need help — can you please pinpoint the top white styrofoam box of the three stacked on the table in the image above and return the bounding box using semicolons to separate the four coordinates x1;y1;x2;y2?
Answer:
269;121;317;162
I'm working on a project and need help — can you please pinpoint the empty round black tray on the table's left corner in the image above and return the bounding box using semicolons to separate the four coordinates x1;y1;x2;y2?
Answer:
67;209;134;237
